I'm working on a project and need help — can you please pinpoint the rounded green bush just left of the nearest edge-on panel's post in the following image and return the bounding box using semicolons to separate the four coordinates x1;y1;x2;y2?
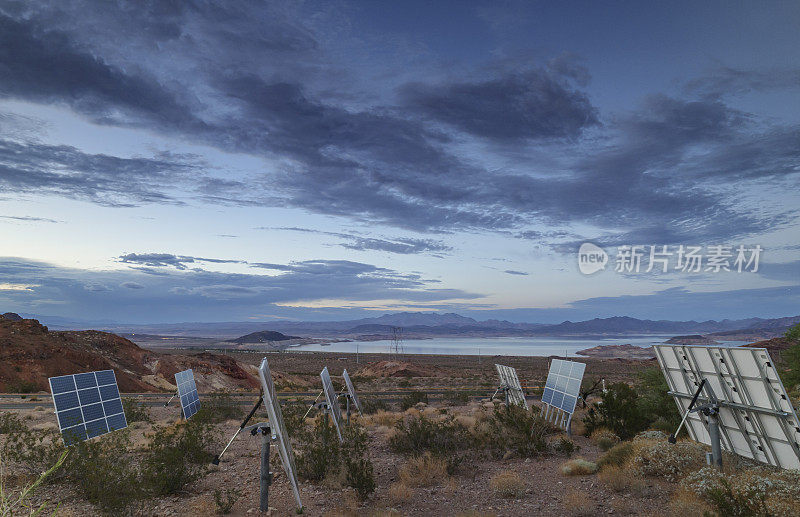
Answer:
142;418;219;495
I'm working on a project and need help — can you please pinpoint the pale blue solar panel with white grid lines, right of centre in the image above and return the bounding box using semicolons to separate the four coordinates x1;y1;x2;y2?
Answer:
542;359;586;430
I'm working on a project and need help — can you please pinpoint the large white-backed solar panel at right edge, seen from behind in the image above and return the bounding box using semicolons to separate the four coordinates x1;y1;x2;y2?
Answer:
653;345;800;469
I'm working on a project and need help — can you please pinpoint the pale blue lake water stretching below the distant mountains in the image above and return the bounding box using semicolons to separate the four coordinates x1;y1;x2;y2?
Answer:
291;335;746;357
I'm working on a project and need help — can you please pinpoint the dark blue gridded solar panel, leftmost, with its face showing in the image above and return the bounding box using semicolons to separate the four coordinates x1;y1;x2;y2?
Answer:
49;370;128;446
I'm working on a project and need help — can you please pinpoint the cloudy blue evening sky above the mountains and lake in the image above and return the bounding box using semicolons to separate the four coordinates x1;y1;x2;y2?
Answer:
0;0;800;323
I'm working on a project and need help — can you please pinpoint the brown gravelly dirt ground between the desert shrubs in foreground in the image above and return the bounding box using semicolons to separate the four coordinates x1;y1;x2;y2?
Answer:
4;396;671;516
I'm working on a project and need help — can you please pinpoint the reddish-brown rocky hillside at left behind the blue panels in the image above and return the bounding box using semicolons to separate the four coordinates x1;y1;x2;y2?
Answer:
0;317;258;392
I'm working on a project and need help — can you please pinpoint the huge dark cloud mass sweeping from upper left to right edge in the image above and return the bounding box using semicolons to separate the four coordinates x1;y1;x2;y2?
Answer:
0;2;798;244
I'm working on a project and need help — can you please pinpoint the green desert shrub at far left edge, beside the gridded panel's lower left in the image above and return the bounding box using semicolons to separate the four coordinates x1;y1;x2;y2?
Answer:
2;418;65;482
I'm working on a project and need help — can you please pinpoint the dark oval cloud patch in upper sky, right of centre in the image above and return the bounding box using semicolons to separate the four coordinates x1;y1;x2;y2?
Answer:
401;69;599;140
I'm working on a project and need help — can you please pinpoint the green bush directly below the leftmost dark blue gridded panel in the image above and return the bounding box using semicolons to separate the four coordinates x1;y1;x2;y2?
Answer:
68;430;145;514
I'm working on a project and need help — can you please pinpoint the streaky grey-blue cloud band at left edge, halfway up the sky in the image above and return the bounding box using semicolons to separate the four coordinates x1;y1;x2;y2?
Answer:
0;139;197;206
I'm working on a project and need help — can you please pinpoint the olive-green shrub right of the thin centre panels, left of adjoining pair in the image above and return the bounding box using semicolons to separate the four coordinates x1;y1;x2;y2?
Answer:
389;415;474;474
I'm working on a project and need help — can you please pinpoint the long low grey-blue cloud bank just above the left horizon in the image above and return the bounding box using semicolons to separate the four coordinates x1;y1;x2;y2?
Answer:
0;257;482;321
